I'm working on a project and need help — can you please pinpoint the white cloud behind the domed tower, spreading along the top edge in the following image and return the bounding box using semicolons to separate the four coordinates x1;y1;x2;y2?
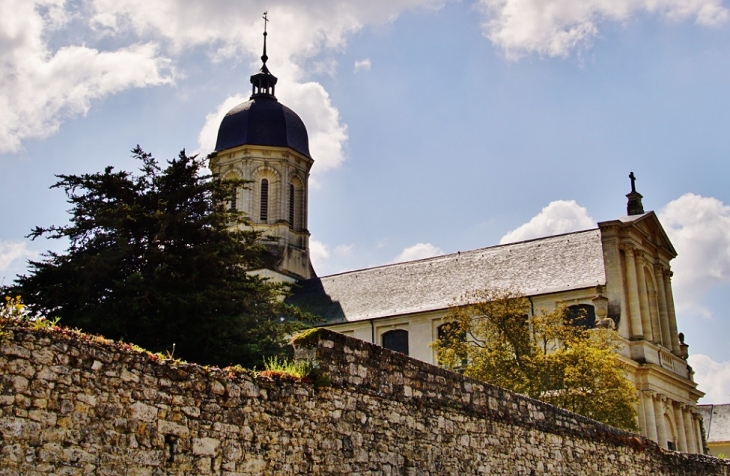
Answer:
90;0;444;172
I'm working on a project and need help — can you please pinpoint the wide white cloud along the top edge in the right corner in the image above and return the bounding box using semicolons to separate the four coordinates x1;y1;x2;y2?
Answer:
478;0;730;59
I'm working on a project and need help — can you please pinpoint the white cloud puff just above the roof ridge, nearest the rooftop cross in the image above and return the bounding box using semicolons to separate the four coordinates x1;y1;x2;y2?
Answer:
499;200;596;244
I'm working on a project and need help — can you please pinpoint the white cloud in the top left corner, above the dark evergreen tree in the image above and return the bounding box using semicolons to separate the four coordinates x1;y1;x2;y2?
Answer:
0;0;173;153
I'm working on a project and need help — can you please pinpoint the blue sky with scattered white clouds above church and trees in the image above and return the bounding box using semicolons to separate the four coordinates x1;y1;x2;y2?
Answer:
0;0;730;403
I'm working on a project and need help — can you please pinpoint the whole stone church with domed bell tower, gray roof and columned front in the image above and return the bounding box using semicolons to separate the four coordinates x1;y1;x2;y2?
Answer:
210;26;703;453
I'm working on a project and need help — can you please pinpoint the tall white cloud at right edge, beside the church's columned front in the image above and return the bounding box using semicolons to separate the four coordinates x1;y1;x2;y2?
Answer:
659;193;730;317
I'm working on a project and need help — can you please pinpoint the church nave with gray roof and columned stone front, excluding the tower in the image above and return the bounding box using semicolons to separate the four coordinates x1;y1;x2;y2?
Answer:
316;212;704;453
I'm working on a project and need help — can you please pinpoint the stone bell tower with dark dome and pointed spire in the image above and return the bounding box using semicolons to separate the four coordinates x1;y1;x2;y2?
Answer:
210;13;314;282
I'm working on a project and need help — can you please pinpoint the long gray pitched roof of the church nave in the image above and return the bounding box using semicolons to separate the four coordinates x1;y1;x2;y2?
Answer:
287;229;606;323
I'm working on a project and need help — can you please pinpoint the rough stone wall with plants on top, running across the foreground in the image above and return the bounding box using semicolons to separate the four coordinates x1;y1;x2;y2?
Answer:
0;327;730;476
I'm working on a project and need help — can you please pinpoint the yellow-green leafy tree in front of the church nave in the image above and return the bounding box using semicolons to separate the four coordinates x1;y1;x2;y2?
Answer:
432;289;637;430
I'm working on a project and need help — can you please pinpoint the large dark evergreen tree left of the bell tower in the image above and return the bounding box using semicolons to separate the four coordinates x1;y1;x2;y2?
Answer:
5;146;301;366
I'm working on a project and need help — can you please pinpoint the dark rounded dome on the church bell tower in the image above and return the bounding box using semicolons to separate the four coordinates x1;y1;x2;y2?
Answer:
215;94;311;158
